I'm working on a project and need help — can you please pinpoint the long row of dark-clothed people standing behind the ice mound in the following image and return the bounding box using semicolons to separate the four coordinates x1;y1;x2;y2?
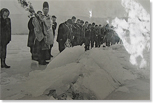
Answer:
57;16;120;52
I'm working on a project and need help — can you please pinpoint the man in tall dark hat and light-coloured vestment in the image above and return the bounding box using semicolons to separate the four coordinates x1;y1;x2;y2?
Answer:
43;2;54;60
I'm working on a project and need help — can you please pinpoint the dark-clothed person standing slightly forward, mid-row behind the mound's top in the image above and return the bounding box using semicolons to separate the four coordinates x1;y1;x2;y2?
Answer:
85;24;91;51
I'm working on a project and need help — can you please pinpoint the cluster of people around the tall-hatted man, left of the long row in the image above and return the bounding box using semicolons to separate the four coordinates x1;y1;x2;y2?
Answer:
27;2;57;65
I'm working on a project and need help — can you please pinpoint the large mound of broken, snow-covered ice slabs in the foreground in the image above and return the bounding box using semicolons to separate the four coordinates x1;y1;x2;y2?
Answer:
23;46;137;99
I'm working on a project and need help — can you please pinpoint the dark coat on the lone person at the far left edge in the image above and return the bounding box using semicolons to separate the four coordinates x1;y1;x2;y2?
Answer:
0;18;11;46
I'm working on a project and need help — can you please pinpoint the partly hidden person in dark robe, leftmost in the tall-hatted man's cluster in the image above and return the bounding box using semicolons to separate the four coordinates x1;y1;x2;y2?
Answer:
27;13;38;60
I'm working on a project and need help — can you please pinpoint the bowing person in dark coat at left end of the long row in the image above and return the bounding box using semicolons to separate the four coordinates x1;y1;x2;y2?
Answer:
56;19;72;52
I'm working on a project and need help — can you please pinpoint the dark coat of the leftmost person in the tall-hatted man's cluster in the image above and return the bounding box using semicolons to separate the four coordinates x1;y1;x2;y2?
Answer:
27;17;35;47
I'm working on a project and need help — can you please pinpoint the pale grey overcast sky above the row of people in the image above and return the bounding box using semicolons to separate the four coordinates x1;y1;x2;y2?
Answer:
0;0;150;32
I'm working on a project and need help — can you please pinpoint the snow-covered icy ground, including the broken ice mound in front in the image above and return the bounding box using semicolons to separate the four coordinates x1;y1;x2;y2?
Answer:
1;35;150;100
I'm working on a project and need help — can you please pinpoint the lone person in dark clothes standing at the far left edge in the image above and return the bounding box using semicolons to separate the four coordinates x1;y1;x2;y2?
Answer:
0;8;11;68
